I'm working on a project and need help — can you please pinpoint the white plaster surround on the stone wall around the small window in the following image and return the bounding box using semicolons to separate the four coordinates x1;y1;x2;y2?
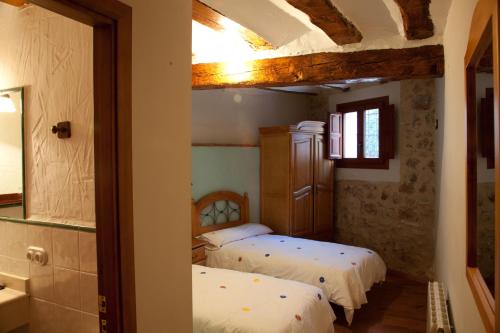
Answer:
329;81;401;182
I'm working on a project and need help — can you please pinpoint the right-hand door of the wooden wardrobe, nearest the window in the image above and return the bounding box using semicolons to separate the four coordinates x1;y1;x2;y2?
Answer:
314;135;334;238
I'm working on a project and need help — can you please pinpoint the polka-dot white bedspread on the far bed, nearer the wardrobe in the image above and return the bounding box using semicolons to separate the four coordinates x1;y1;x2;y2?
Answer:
206;235;387;323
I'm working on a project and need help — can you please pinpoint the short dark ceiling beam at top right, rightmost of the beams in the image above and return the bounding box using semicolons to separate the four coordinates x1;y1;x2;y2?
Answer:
394;0;434;40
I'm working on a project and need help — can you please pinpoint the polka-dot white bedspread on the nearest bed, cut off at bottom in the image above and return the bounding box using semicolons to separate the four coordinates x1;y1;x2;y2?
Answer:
193;265;335;333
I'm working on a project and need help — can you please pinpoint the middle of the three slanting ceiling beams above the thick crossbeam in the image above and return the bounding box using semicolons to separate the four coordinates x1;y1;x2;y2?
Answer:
287;0;363;45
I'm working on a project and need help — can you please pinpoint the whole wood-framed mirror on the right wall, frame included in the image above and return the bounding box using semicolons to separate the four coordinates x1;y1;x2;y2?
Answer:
466;0;500;332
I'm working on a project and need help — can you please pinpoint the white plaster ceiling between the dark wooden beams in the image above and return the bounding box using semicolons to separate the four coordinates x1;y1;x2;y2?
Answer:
193;0;451;63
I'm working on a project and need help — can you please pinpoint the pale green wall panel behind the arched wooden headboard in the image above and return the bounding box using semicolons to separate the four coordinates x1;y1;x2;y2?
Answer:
192;147;260;222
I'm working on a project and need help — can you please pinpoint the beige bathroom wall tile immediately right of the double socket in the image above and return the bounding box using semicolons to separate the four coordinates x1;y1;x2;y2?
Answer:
52;228;80;270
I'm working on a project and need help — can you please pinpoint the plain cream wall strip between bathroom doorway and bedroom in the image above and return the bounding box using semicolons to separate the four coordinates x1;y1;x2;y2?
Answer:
119;0;192;333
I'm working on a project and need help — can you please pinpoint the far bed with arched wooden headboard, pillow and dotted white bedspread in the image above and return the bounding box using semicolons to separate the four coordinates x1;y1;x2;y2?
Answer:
192;192;387;323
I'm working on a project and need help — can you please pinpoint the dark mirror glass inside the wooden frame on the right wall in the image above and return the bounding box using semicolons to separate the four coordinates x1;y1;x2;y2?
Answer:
475;40;495;295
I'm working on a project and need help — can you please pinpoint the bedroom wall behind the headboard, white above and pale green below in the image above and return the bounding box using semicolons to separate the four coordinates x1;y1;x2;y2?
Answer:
192;88;311;222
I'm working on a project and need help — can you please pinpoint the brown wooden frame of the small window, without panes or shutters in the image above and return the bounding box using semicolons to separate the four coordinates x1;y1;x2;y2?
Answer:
336;96;390;169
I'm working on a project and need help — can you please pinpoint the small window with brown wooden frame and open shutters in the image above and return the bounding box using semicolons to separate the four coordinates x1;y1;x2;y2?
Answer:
329;96;395;169
